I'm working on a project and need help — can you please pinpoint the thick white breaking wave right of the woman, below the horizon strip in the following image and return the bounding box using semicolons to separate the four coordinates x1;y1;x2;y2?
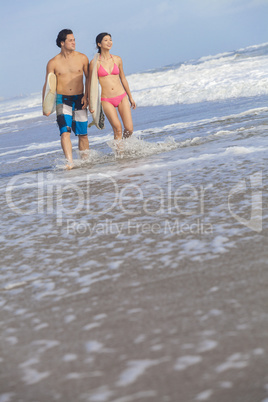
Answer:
128;55;268;106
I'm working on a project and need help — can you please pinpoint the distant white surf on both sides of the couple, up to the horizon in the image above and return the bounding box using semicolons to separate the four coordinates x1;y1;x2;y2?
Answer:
0;43;268;124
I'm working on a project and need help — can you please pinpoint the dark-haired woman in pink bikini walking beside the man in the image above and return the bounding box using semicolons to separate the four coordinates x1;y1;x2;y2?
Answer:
88;32;136;140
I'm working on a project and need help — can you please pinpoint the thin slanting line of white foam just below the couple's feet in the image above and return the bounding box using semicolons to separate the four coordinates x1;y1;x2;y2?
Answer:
4;139;268;191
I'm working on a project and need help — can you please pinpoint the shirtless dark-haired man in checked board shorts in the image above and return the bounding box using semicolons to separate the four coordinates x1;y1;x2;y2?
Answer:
43;29;89;169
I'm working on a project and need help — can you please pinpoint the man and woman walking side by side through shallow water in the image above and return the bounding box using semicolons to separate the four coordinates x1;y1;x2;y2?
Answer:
43;29;136;169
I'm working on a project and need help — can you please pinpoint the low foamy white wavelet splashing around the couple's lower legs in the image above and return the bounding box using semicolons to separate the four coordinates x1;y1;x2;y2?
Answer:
0;103;268;169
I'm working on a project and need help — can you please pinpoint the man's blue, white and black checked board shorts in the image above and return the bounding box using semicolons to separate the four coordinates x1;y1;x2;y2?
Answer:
56;94;87;135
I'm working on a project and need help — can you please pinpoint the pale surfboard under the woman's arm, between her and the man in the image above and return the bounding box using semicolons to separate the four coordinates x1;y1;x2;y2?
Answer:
88;53;105;130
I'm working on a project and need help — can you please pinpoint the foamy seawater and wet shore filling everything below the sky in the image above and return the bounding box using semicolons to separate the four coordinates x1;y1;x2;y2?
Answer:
0;43;268;402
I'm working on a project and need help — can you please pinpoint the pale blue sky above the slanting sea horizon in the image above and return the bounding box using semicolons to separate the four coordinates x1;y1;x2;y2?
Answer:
0;0;268;99
